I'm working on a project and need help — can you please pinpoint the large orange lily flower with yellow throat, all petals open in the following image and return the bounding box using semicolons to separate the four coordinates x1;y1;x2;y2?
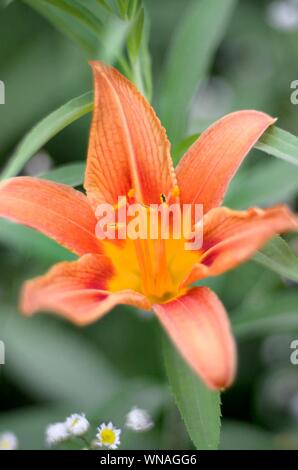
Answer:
0;62;298;389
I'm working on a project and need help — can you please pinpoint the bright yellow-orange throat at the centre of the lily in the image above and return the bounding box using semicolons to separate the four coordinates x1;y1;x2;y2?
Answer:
103;194;199;303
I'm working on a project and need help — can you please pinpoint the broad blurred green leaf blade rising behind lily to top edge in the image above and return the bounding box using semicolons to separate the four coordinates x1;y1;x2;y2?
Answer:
157;0;236;144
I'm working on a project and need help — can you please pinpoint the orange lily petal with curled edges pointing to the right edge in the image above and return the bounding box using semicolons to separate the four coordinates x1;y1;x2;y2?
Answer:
184;205;298;284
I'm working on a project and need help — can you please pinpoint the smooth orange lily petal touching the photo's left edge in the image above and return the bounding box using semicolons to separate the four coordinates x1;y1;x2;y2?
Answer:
0;176;101;255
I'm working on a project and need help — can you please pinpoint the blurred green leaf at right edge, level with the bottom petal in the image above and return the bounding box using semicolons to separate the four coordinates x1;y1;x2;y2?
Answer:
231;291;298;339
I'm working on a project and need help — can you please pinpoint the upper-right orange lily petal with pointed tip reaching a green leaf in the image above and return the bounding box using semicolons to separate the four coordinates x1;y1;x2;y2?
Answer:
176;110;275;213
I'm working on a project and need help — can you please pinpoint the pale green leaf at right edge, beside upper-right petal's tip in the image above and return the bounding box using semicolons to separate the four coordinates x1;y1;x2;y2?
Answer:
255;126;298;165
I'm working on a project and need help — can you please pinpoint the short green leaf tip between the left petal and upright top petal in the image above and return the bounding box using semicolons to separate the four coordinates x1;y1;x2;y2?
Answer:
38;162;86;187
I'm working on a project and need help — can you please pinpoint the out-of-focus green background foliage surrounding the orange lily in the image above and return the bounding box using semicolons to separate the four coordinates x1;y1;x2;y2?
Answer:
0;0;298;449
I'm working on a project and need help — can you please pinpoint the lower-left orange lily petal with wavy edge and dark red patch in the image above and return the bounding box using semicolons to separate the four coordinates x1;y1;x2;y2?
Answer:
21;255;148;325
